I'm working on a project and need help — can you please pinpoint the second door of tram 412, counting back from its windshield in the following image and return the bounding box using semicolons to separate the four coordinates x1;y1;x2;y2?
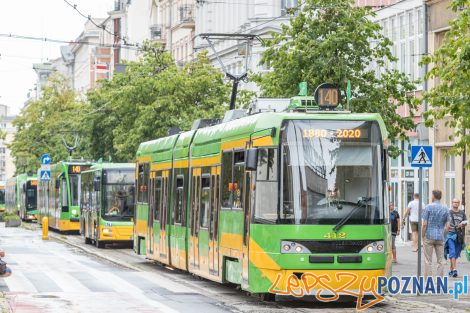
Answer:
209;166;220;276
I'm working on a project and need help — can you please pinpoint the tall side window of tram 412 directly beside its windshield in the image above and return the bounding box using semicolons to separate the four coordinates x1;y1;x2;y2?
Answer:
254;148;279;223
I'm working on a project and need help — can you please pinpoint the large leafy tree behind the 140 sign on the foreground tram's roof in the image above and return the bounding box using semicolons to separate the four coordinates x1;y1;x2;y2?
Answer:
254;0;416;144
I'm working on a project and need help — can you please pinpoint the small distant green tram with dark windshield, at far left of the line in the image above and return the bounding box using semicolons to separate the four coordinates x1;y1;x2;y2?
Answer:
5;174;38;222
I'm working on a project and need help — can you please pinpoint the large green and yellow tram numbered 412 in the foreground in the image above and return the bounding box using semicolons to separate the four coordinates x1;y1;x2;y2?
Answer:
134;97;391;294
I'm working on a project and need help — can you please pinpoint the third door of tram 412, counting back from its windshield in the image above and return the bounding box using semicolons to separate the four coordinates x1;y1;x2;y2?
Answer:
189;168;201;269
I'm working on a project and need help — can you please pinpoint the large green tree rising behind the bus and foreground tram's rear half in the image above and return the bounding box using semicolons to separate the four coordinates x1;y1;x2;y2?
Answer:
86;43;230;161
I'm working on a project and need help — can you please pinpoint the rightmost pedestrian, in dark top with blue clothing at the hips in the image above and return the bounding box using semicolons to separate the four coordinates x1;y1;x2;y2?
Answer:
444;199;468;277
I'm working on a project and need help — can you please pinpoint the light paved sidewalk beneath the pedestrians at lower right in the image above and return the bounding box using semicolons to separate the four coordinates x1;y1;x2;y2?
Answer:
392;241;470;311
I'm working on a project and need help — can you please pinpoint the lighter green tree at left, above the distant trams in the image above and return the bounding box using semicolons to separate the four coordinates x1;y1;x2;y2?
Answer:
9;75;88;174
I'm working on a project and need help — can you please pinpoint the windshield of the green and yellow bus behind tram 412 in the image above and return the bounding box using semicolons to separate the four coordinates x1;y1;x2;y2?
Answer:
101;170;135;221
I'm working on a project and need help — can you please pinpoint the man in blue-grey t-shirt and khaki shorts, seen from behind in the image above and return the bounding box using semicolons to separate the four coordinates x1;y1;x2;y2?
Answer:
421;190;450;279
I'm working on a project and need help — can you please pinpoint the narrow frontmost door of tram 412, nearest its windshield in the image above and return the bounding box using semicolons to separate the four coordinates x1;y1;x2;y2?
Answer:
242;171;254;287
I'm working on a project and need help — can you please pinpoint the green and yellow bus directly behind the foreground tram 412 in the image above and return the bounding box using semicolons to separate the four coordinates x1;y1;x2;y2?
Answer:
80;163;135;248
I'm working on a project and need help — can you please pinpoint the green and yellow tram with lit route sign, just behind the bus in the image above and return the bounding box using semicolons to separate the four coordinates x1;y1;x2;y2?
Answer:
38;160;92;234
